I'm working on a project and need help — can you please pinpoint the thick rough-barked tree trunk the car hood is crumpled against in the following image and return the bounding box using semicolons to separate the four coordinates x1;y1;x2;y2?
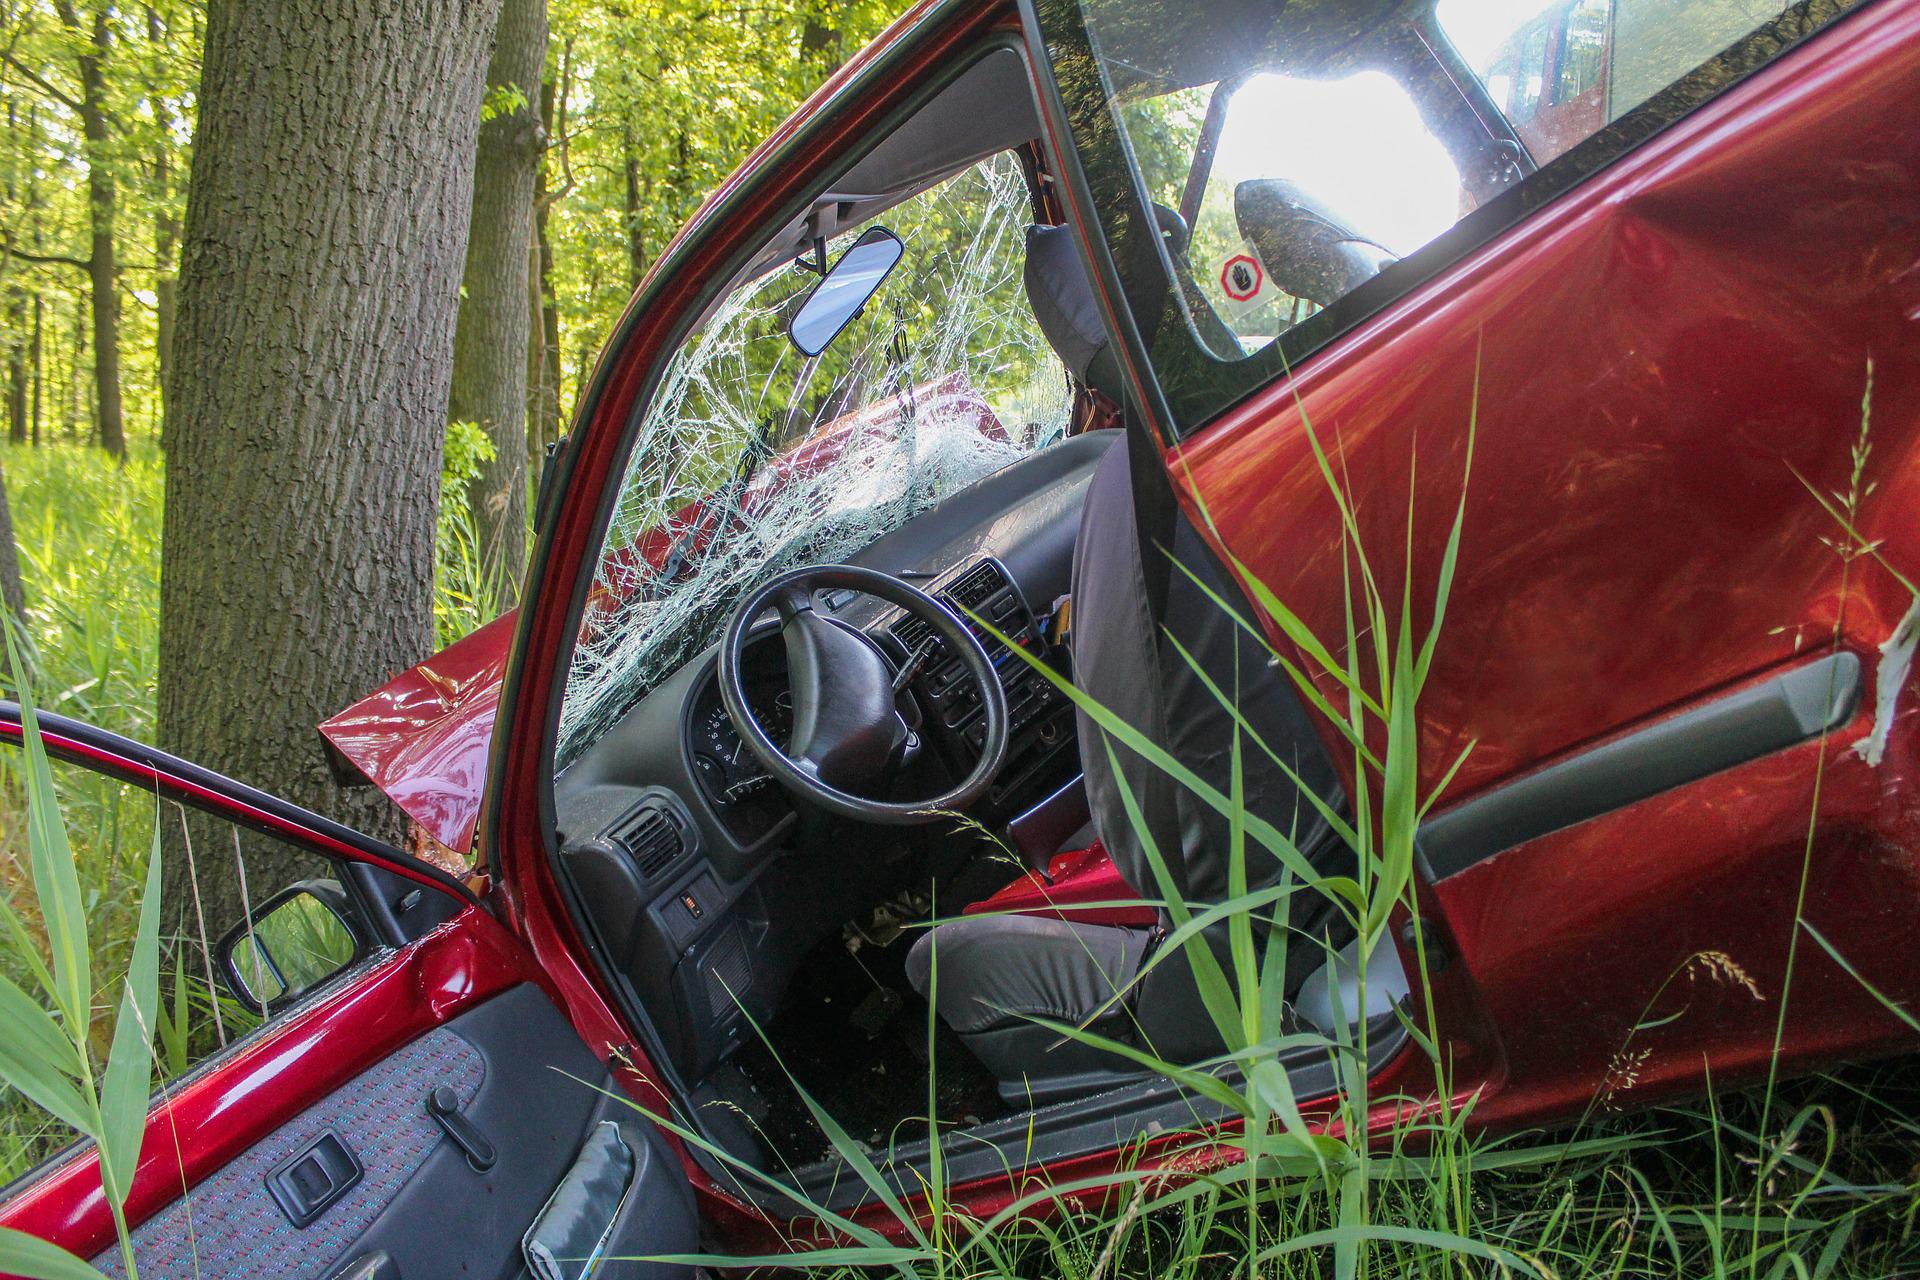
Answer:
159;0;499;929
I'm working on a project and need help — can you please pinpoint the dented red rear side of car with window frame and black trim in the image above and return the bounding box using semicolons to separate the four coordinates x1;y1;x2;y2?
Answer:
1029;0;1920;1123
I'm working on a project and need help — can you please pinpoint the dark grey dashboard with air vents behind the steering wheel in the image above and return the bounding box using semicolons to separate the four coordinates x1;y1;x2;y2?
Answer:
553;432;1117;1080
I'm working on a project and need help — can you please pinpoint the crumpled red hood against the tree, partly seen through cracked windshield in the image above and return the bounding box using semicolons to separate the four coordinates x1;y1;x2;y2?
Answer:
321;374;1008;852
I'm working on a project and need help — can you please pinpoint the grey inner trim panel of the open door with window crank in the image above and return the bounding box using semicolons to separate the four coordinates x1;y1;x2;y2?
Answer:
94;986;697;1280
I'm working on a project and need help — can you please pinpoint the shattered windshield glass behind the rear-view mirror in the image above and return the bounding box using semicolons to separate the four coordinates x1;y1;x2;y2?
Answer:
559;155;1071;768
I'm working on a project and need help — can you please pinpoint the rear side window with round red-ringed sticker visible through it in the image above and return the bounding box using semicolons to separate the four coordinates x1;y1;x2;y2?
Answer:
1037;0;1853;430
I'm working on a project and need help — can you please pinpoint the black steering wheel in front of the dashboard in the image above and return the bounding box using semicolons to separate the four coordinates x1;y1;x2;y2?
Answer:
720;564;1010;825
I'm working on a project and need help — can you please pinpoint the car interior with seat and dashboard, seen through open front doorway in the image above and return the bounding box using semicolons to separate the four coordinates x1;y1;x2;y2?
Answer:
553;46;1443;1182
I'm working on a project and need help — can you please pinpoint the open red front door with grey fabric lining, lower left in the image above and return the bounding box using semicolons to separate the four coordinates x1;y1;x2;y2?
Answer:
0;702;697;1280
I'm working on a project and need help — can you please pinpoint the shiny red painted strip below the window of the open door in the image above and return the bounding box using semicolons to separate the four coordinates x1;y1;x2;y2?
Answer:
0;908;541;1257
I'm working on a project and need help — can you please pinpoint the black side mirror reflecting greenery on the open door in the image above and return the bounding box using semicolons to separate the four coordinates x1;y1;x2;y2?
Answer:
213;881;361;1015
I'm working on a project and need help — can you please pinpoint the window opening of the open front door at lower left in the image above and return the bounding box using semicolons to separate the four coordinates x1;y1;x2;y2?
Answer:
0;747;365;1184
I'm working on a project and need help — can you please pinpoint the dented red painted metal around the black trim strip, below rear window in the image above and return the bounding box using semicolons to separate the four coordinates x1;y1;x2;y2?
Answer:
1175;0;1920;1123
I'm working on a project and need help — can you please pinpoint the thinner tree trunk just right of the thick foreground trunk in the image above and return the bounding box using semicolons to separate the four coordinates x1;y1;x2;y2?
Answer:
447;0;547;608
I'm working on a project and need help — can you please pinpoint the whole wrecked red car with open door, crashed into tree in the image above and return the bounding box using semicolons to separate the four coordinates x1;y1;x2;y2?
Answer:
0;0;1920;1278
